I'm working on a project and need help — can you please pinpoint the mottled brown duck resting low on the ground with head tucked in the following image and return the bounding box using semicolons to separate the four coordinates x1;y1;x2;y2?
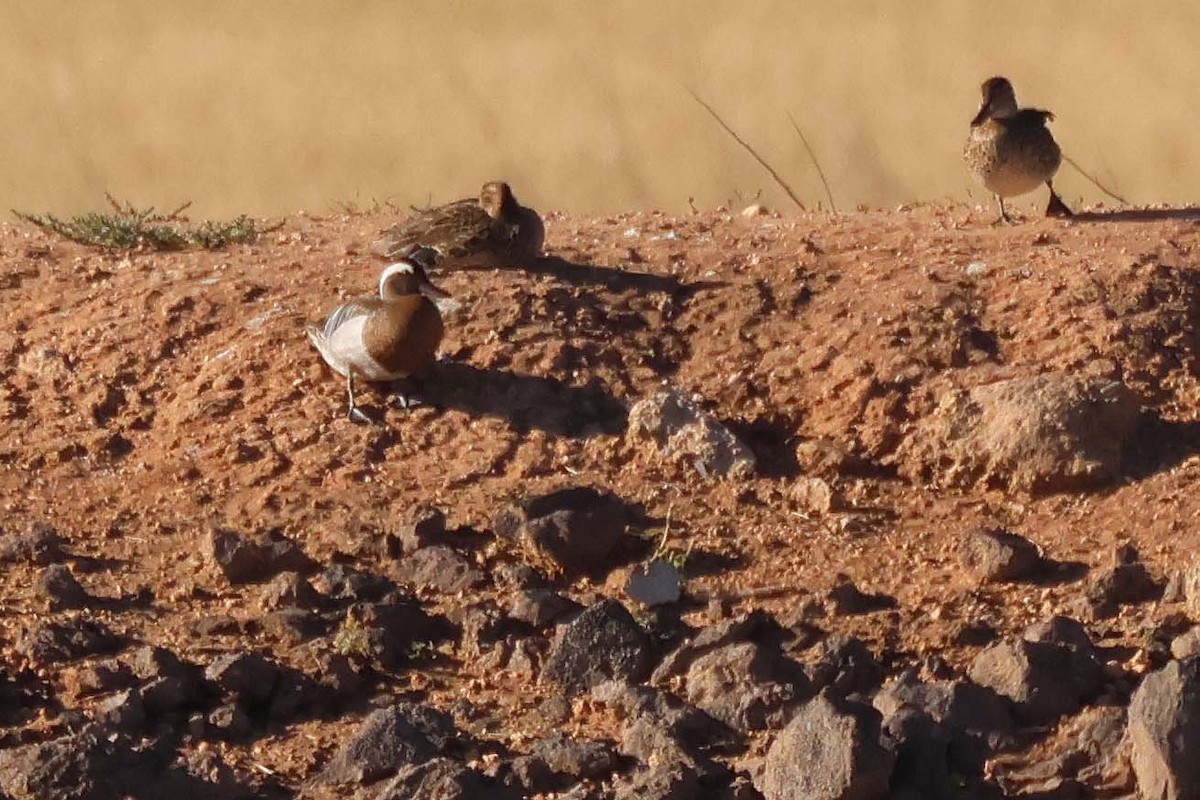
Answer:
371;181;546;269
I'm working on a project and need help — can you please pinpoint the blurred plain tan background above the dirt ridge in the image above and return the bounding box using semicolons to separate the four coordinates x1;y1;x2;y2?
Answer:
0;0;1200;215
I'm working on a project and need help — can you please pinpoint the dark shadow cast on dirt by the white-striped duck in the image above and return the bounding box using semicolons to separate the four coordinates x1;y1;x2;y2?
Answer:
420;361;628;438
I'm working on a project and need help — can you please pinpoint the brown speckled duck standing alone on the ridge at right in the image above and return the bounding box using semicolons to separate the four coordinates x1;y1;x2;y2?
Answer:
962;76;1072;223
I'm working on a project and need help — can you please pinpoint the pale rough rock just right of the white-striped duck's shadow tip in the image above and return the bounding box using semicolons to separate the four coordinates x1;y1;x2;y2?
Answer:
626;387;756;477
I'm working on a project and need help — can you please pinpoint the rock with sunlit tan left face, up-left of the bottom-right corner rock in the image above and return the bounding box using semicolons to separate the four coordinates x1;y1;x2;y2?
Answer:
970;639;1104;724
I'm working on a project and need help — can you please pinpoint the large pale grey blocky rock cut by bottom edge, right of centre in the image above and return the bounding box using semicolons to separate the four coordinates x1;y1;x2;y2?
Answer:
758;694;895;800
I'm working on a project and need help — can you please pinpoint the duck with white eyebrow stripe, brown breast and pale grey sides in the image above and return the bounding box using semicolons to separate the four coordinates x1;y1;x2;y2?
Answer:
307;248;457;422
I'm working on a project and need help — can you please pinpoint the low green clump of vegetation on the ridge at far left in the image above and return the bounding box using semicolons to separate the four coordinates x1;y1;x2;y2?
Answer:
13;194;282;249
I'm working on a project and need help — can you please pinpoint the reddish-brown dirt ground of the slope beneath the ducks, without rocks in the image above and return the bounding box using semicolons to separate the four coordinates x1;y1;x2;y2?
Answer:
0;205;1200;787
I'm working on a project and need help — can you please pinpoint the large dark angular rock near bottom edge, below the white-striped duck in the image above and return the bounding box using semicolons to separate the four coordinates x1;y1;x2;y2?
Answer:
320;703;458;784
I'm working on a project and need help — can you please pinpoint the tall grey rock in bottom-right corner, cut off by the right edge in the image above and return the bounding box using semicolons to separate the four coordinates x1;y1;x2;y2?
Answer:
1129;656;1200;800
